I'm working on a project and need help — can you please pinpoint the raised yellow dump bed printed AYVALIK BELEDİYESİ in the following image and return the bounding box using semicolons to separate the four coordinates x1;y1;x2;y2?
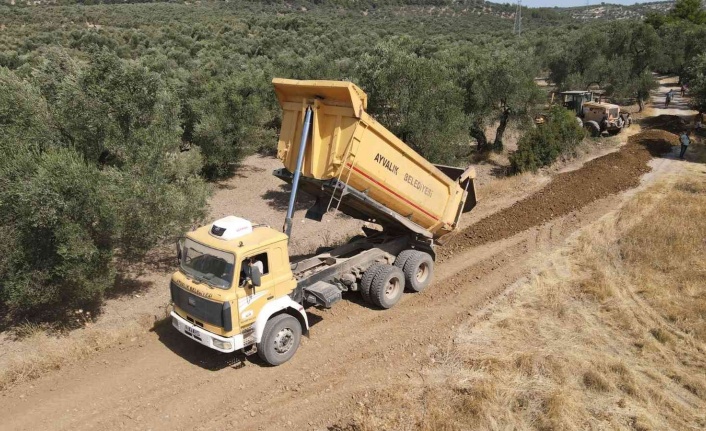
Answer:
272;78;476;239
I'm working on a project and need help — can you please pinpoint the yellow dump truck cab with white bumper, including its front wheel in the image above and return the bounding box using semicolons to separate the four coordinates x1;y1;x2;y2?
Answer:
170;216;308;364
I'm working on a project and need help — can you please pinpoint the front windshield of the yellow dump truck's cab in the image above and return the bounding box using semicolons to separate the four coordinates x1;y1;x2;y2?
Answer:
180;238;235;289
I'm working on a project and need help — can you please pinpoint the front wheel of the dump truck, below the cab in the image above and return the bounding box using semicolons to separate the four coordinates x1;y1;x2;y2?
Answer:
257;314;302;365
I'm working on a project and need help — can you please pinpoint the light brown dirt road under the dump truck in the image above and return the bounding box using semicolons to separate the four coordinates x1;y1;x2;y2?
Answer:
0;88;692;430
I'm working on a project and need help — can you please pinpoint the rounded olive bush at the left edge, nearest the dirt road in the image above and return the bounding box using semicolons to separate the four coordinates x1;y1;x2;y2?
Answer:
0;148;117;313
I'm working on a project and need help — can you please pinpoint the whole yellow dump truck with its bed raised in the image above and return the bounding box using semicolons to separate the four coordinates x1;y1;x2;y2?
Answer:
170;79;476;365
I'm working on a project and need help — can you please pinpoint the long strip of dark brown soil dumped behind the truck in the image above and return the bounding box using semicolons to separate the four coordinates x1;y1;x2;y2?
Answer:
438;134;678;261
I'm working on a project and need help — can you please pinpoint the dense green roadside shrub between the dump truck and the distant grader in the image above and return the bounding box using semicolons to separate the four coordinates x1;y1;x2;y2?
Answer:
510;106;585;173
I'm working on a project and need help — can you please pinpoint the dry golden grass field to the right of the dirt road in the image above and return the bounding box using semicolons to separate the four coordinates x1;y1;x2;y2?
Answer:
347;173;706;430
